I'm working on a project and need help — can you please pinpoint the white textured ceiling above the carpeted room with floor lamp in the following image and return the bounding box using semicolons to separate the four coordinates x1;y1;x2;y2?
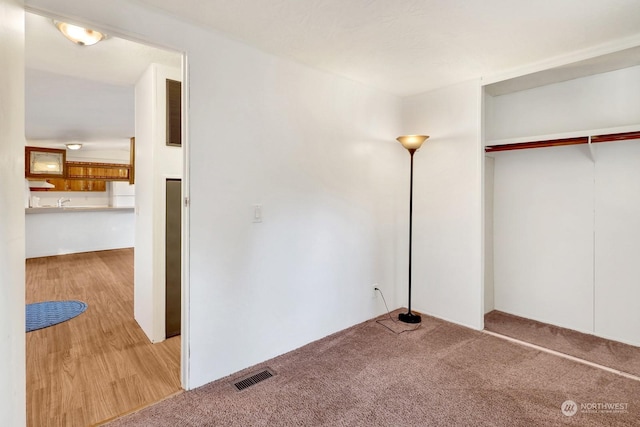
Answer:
132;0;640;95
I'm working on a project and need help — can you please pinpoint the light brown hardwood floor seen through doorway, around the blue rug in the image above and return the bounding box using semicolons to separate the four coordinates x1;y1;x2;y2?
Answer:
26;249;181;427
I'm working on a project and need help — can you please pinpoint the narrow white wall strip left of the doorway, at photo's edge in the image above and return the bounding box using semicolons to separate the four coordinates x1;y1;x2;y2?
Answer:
0;0;26;426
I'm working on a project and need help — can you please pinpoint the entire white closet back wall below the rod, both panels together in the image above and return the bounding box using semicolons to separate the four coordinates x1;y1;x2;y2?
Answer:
494;140;640;345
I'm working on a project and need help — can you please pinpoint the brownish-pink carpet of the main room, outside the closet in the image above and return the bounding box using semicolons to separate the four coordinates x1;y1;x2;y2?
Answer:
109;310;640;427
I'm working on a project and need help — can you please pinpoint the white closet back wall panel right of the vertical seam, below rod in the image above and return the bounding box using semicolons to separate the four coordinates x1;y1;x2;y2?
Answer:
594;140;640;346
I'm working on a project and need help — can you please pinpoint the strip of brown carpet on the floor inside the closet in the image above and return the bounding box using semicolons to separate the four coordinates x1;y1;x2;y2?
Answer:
484;310;640;378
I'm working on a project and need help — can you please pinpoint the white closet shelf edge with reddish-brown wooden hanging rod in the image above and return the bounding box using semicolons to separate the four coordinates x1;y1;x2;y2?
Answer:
484;124;640;153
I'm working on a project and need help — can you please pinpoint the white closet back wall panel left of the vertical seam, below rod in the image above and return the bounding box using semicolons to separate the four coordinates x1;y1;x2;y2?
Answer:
493;146;593;332
